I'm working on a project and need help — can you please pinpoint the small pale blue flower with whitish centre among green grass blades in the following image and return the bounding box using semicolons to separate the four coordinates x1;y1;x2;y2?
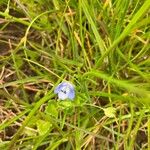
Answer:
54;81;75;100
